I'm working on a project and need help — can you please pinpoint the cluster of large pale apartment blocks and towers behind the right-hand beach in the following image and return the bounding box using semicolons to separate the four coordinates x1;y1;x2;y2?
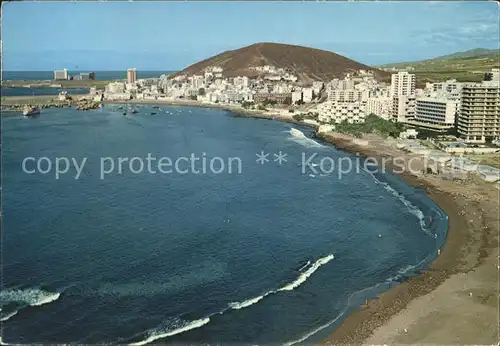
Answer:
316;69;500;143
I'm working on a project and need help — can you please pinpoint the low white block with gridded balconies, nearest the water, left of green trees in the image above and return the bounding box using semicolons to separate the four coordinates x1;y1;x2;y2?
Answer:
316;102;366;124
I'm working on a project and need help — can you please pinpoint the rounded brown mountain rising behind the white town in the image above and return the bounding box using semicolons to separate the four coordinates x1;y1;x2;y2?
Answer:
172;43;390;84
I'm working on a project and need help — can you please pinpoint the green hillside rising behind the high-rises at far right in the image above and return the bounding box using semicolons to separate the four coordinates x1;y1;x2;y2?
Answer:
383;48;500;83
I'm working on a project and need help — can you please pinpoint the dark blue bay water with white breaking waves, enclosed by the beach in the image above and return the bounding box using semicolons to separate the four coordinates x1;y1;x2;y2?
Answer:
0;105;448;345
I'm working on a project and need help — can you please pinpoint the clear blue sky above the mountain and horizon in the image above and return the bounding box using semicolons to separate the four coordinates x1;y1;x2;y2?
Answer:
2;1;499;70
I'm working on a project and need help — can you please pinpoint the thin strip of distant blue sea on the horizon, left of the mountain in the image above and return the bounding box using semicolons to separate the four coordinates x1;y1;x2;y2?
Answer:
2;70;172;81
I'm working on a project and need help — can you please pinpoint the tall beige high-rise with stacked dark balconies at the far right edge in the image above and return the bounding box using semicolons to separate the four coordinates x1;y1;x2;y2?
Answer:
458;70;500;143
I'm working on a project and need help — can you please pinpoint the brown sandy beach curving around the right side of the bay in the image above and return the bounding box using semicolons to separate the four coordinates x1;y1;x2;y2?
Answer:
323;134;499;345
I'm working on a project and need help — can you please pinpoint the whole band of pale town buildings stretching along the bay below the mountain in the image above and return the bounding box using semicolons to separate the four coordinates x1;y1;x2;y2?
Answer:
104;66;500;143
